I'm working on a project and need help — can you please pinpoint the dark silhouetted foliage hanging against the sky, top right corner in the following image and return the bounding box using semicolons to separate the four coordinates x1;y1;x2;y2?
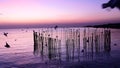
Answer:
102;0;120;10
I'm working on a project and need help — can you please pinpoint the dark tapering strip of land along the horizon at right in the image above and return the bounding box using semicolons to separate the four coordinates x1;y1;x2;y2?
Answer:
85;23;120;29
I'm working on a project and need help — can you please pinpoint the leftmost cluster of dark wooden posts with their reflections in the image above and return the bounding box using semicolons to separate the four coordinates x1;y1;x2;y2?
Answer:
33;31;61;59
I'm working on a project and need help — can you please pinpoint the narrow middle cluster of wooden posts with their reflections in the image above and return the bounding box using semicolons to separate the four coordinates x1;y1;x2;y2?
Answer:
65;29;80;61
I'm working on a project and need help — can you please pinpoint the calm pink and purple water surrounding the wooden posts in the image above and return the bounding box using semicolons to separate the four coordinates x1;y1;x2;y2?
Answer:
0;28;120;68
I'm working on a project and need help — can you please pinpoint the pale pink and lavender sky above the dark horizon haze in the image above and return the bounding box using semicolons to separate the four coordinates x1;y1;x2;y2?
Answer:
0;0;120;25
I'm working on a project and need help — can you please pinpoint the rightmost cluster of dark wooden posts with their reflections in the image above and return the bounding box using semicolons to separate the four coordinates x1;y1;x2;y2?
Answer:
83;28;111;58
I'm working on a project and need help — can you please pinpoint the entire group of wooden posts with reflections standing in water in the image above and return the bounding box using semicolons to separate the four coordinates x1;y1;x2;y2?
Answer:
33;28;111;62
